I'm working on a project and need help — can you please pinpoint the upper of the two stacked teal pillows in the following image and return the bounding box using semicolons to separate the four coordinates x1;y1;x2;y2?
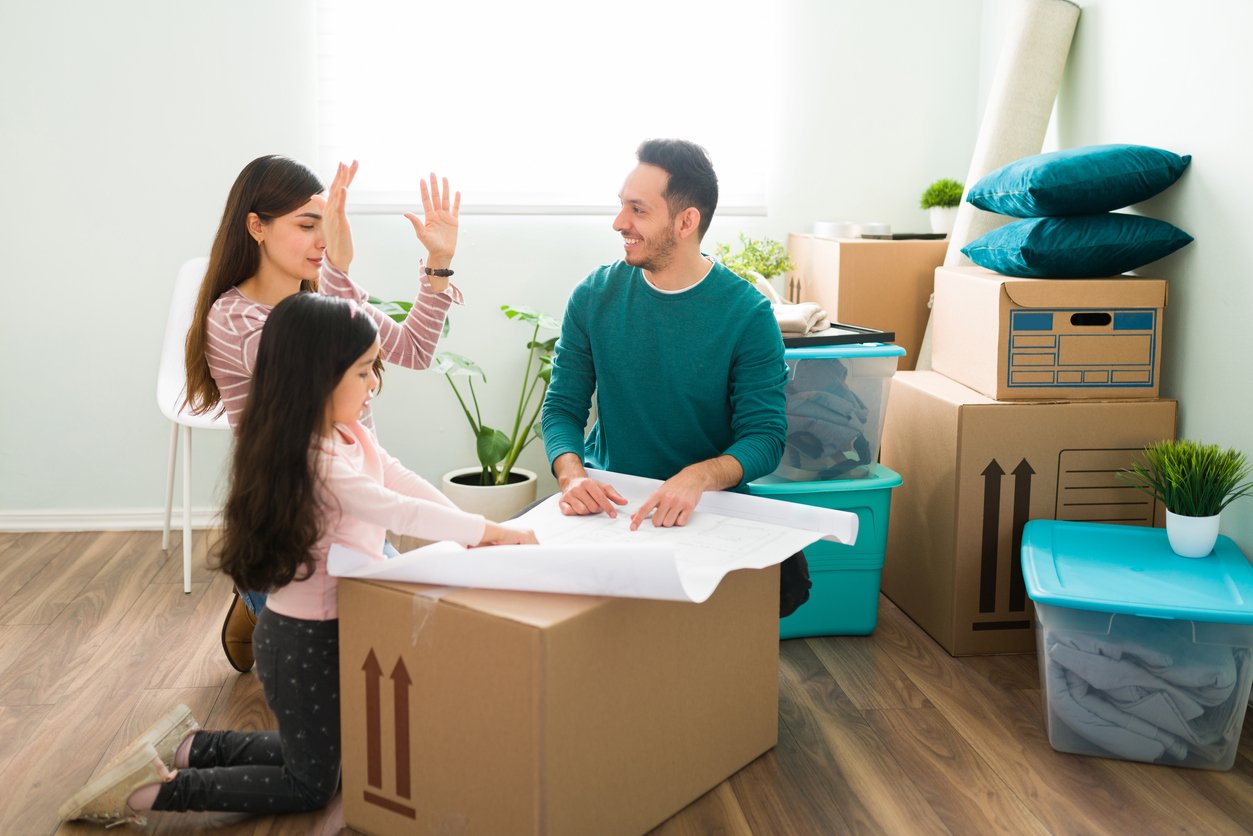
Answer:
966;145;1192;218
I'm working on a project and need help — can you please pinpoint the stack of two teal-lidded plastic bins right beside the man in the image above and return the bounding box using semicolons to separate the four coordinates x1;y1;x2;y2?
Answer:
748;342;905;638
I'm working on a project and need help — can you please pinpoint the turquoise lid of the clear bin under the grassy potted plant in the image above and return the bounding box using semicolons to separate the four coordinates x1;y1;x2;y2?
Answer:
1022;520;1253;624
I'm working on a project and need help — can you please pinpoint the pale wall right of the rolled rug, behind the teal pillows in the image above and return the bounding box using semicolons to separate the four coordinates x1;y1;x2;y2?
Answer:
1056;0;1253;555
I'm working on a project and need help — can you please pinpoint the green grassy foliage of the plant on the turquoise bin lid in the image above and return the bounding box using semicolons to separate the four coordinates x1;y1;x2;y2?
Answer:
1118;440;1253;516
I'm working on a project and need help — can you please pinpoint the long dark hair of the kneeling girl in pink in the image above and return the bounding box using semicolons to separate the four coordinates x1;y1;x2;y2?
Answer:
218;293;378;592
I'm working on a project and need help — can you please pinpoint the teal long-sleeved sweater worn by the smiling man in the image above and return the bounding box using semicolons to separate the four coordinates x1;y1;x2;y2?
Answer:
543;261;787;484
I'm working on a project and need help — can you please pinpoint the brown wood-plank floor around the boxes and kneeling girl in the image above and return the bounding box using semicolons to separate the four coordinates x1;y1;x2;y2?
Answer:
0;531;1253;836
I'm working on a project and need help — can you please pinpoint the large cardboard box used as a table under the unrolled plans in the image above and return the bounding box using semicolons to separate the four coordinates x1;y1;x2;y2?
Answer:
340;567;778;836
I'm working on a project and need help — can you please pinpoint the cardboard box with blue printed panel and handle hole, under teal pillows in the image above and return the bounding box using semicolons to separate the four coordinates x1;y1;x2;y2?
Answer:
931;267;1167;400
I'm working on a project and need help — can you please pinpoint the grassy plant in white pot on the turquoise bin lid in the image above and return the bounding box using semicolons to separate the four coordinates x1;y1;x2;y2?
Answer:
1119;440;1253;558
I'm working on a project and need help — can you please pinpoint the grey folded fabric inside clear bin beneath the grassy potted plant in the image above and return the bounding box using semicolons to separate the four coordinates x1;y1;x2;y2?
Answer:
1044;619;1249;762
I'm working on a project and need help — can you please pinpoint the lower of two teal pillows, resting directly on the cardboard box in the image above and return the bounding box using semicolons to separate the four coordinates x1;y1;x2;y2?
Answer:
961;214;1192;278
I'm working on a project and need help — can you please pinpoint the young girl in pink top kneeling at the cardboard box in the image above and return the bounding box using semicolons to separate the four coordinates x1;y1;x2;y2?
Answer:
60;293;535;825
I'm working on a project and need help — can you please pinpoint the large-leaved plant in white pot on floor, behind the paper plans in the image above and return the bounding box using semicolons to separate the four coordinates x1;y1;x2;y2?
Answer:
370;298;561;523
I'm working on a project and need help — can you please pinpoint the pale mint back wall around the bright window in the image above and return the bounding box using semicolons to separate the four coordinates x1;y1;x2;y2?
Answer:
0;0;980;521
